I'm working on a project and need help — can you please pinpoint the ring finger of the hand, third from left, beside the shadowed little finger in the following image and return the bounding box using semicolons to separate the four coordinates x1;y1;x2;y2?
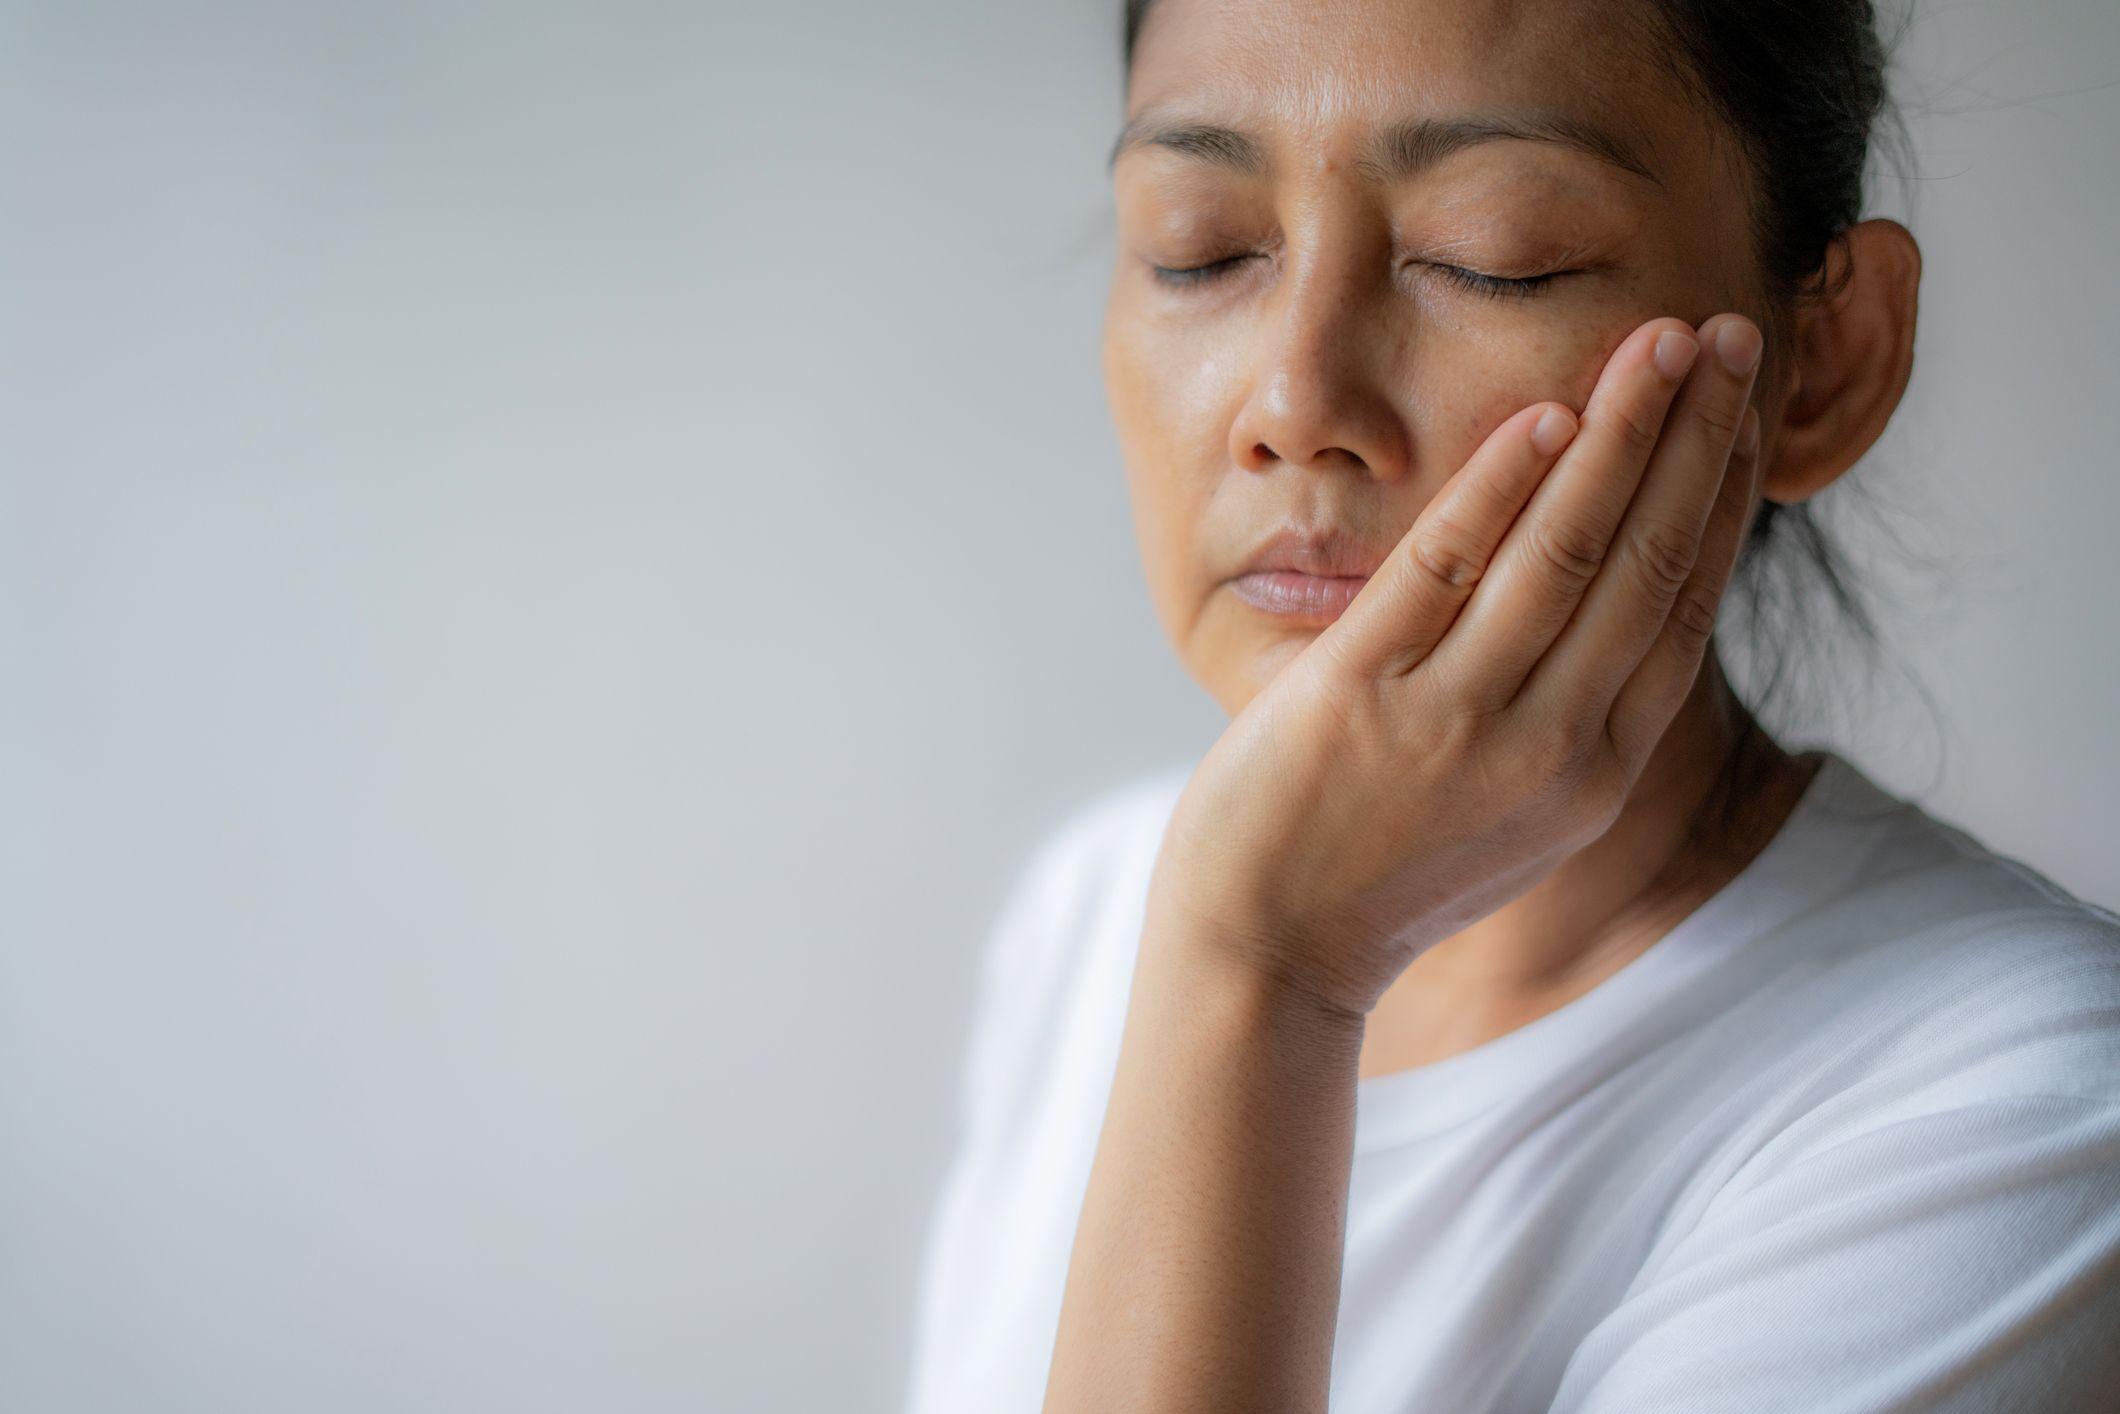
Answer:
1522;314;1764;721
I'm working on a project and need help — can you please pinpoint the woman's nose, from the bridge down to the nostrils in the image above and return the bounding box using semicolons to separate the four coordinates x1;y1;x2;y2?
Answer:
1230;225;1408;481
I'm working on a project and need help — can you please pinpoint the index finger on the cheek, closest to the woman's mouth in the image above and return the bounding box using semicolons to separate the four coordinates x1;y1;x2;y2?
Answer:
1319;403;1577;676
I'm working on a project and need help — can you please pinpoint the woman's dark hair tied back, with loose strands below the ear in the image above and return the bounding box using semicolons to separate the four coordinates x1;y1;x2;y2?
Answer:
1121;0;1912;846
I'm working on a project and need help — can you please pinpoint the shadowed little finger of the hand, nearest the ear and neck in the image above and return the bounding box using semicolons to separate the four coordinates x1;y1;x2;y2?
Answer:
1605;407;1764;776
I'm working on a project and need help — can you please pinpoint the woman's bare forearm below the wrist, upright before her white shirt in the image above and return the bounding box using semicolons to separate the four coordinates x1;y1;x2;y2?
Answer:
1045;914;1363;1414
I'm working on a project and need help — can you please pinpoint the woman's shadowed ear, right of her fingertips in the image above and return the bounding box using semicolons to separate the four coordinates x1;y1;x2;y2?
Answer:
1760;216;1921;502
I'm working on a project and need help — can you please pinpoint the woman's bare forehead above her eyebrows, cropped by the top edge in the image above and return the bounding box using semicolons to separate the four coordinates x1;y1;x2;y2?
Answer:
1113;0;1717;191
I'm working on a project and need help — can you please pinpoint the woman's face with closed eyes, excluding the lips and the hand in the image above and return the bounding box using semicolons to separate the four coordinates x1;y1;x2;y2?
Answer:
1102;0;1770;714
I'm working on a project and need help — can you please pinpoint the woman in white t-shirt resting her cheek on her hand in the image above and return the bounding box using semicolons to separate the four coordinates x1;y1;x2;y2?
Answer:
909;0;2120;1414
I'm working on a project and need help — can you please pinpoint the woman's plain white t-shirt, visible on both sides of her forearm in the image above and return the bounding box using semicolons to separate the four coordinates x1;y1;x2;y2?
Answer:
905;753;2120;1414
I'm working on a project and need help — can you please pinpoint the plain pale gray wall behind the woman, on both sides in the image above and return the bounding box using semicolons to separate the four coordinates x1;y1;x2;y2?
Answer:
0;0;2120;1412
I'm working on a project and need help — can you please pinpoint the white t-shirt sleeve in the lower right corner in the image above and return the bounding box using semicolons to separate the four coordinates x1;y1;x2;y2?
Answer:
1552;911;2120;1414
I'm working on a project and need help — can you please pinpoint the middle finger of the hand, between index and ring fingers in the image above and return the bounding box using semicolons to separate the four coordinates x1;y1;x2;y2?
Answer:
1429;318;1700;710
